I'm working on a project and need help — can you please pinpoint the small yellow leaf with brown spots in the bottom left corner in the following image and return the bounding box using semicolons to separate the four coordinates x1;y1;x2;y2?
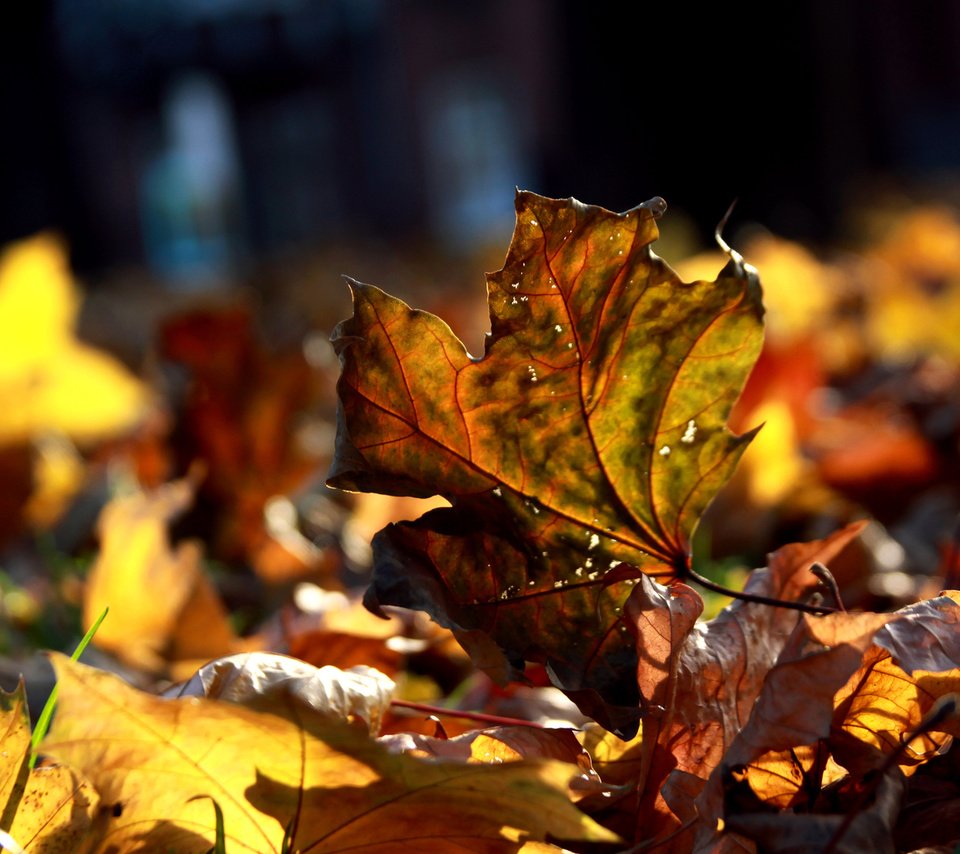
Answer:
0;681;97;854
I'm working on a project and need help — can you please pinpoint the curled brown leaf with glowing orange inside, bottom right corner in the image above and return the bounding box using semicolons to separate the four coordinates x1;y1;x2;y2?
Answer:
671;593;960;851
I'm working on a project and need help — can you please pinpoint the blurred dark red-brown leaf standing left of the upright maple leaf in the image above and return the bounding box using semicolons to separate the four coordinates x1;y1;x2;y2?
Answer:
159;307;330;584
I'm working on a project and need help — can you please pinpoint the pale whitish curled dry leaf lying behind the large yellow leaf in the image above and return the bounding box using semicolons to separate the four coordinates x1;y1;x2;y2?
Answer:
166;652;396;735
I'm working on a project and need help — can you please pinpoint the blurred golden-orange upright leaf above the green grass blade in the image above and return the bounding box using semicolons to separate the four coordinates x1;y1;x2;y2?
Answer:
83;479;238;675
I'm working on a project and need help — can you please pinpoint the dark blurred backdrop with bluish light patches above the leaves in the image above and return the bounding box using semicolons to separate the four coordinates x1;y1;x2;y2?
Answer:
0;0;960;278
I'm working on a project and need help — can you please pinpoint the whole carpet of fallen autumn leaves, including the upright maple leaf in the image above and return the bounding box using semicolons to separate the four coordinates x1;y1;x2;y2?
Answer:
0;193;960;852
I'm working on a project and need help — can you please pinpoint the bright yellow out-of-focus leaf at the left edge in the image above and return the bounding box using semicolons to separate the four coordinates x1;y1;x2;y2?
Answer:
0;235;147;443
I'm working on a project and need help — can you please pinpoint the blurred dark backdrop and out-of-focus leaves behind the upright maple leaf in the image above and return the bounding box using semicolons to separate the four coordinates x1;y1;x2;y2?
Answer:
0;0;960;704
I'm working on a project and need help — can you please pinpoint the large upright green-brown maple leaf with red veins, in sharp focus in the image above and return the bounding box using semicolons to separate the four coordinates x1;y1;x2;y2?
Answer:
329;192;763;736
